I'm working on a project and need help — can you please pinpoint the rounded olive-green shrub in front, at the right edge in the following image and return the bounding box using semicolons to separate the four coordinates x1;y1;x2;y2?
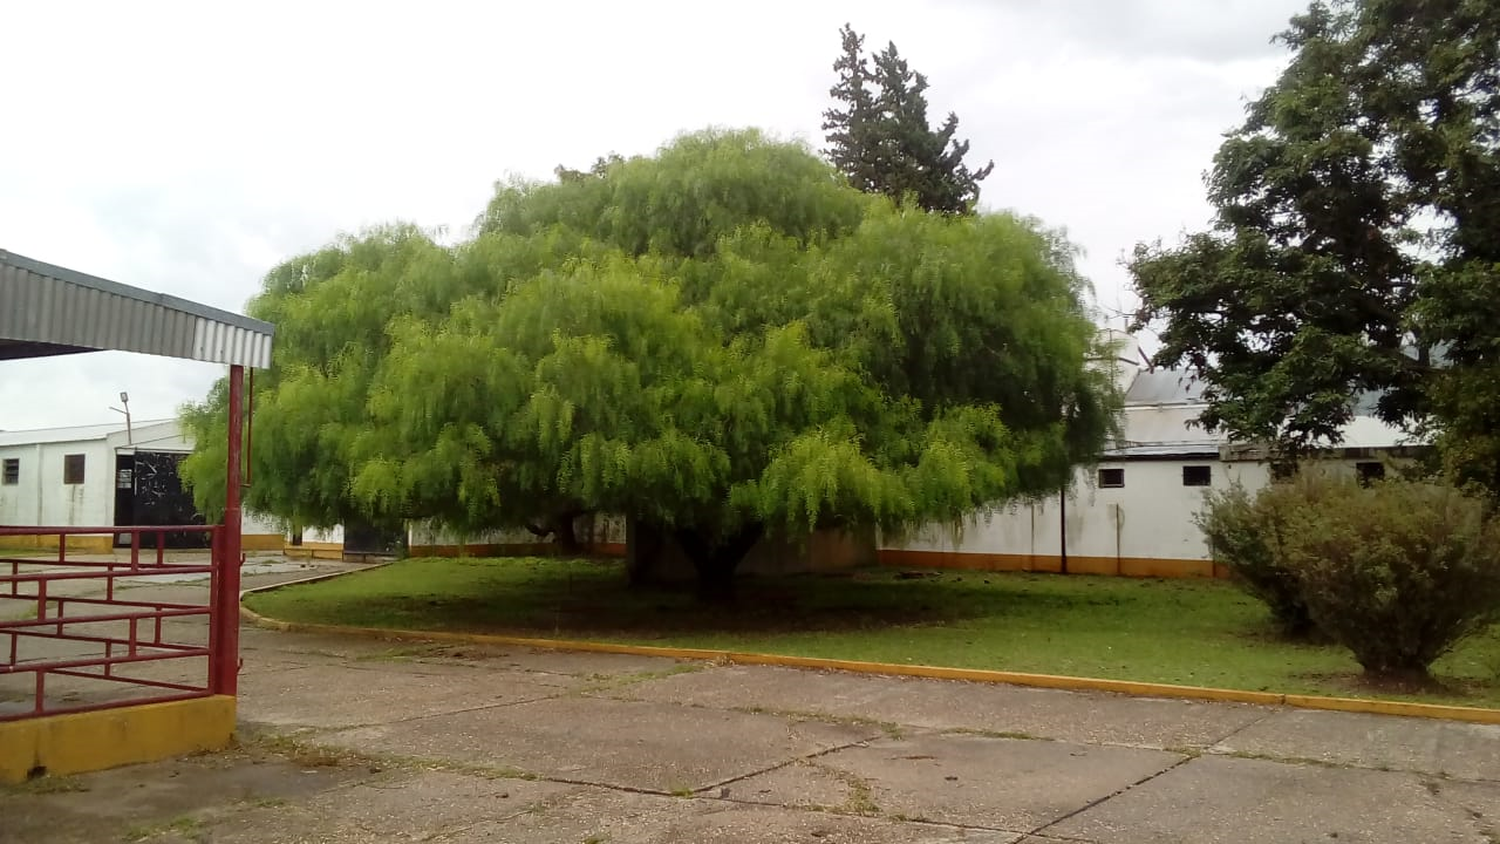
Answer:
1278;474;1500;678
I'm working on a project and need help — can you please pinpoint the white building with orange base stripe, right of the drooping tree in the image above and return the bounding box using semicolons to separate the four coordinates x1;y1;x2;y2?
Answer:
881;336;1409;577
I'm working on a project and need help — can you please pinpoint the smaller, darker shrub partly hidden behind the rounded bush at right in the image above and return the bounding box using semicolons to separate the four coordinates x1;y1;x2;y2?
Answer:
1197;484;1314;639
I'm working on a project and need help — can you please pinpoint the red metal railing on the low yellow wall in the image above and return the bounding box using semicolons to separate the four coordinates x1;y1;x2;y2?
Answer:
0;525;239;721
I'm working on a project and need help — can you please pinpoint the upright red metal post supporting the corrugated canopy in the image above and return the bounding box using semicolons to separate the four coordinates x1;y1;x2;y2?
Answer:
210;366;245;696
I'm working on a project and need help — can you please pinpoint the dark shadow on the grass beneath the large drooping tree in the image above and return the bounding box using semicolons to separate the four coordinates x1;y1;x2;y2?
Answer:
252;558;1236;639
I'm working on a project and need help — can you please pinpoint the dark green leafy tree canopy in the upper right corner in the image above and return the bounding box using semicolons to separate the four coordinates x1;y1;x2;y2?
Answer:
1130;0;1500;490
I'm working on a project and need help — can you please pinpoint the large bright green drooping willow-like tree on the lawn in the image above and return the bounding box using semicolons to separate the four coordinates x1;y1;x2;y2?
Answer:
189;132;1115;585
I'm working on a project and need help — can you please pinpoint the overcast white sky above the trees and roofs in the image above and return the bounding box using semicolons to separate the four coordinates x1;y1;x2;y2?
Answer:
0;0;1305;430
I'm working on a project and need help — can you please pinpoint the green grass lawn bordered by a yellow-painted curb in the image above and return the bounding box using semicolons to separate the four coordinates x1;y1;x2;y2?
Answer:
248;558;1500;706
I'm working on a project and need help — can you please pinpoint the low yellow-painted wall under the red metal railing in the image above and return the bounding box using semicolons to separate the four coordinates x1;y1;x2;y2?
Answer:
0;696;234;783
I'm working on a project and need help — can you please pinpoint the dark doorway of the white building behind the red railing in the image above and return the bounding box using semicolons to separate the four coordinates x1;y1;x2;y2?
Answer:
114;451;209;549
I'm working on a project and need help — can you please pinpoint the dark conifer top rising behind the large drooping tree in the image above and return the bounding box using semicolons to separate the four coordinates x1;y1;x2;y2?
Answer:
824;24;995;214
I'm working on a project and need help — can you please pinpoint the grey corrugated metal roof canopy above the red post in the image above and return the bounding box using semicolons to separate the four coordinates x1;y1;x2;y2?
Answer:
0;249;276;369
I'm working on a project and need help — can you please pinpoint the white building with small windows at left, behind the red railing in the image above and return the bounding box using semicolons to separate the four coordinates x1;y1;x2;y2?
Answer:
0;420;282;552
